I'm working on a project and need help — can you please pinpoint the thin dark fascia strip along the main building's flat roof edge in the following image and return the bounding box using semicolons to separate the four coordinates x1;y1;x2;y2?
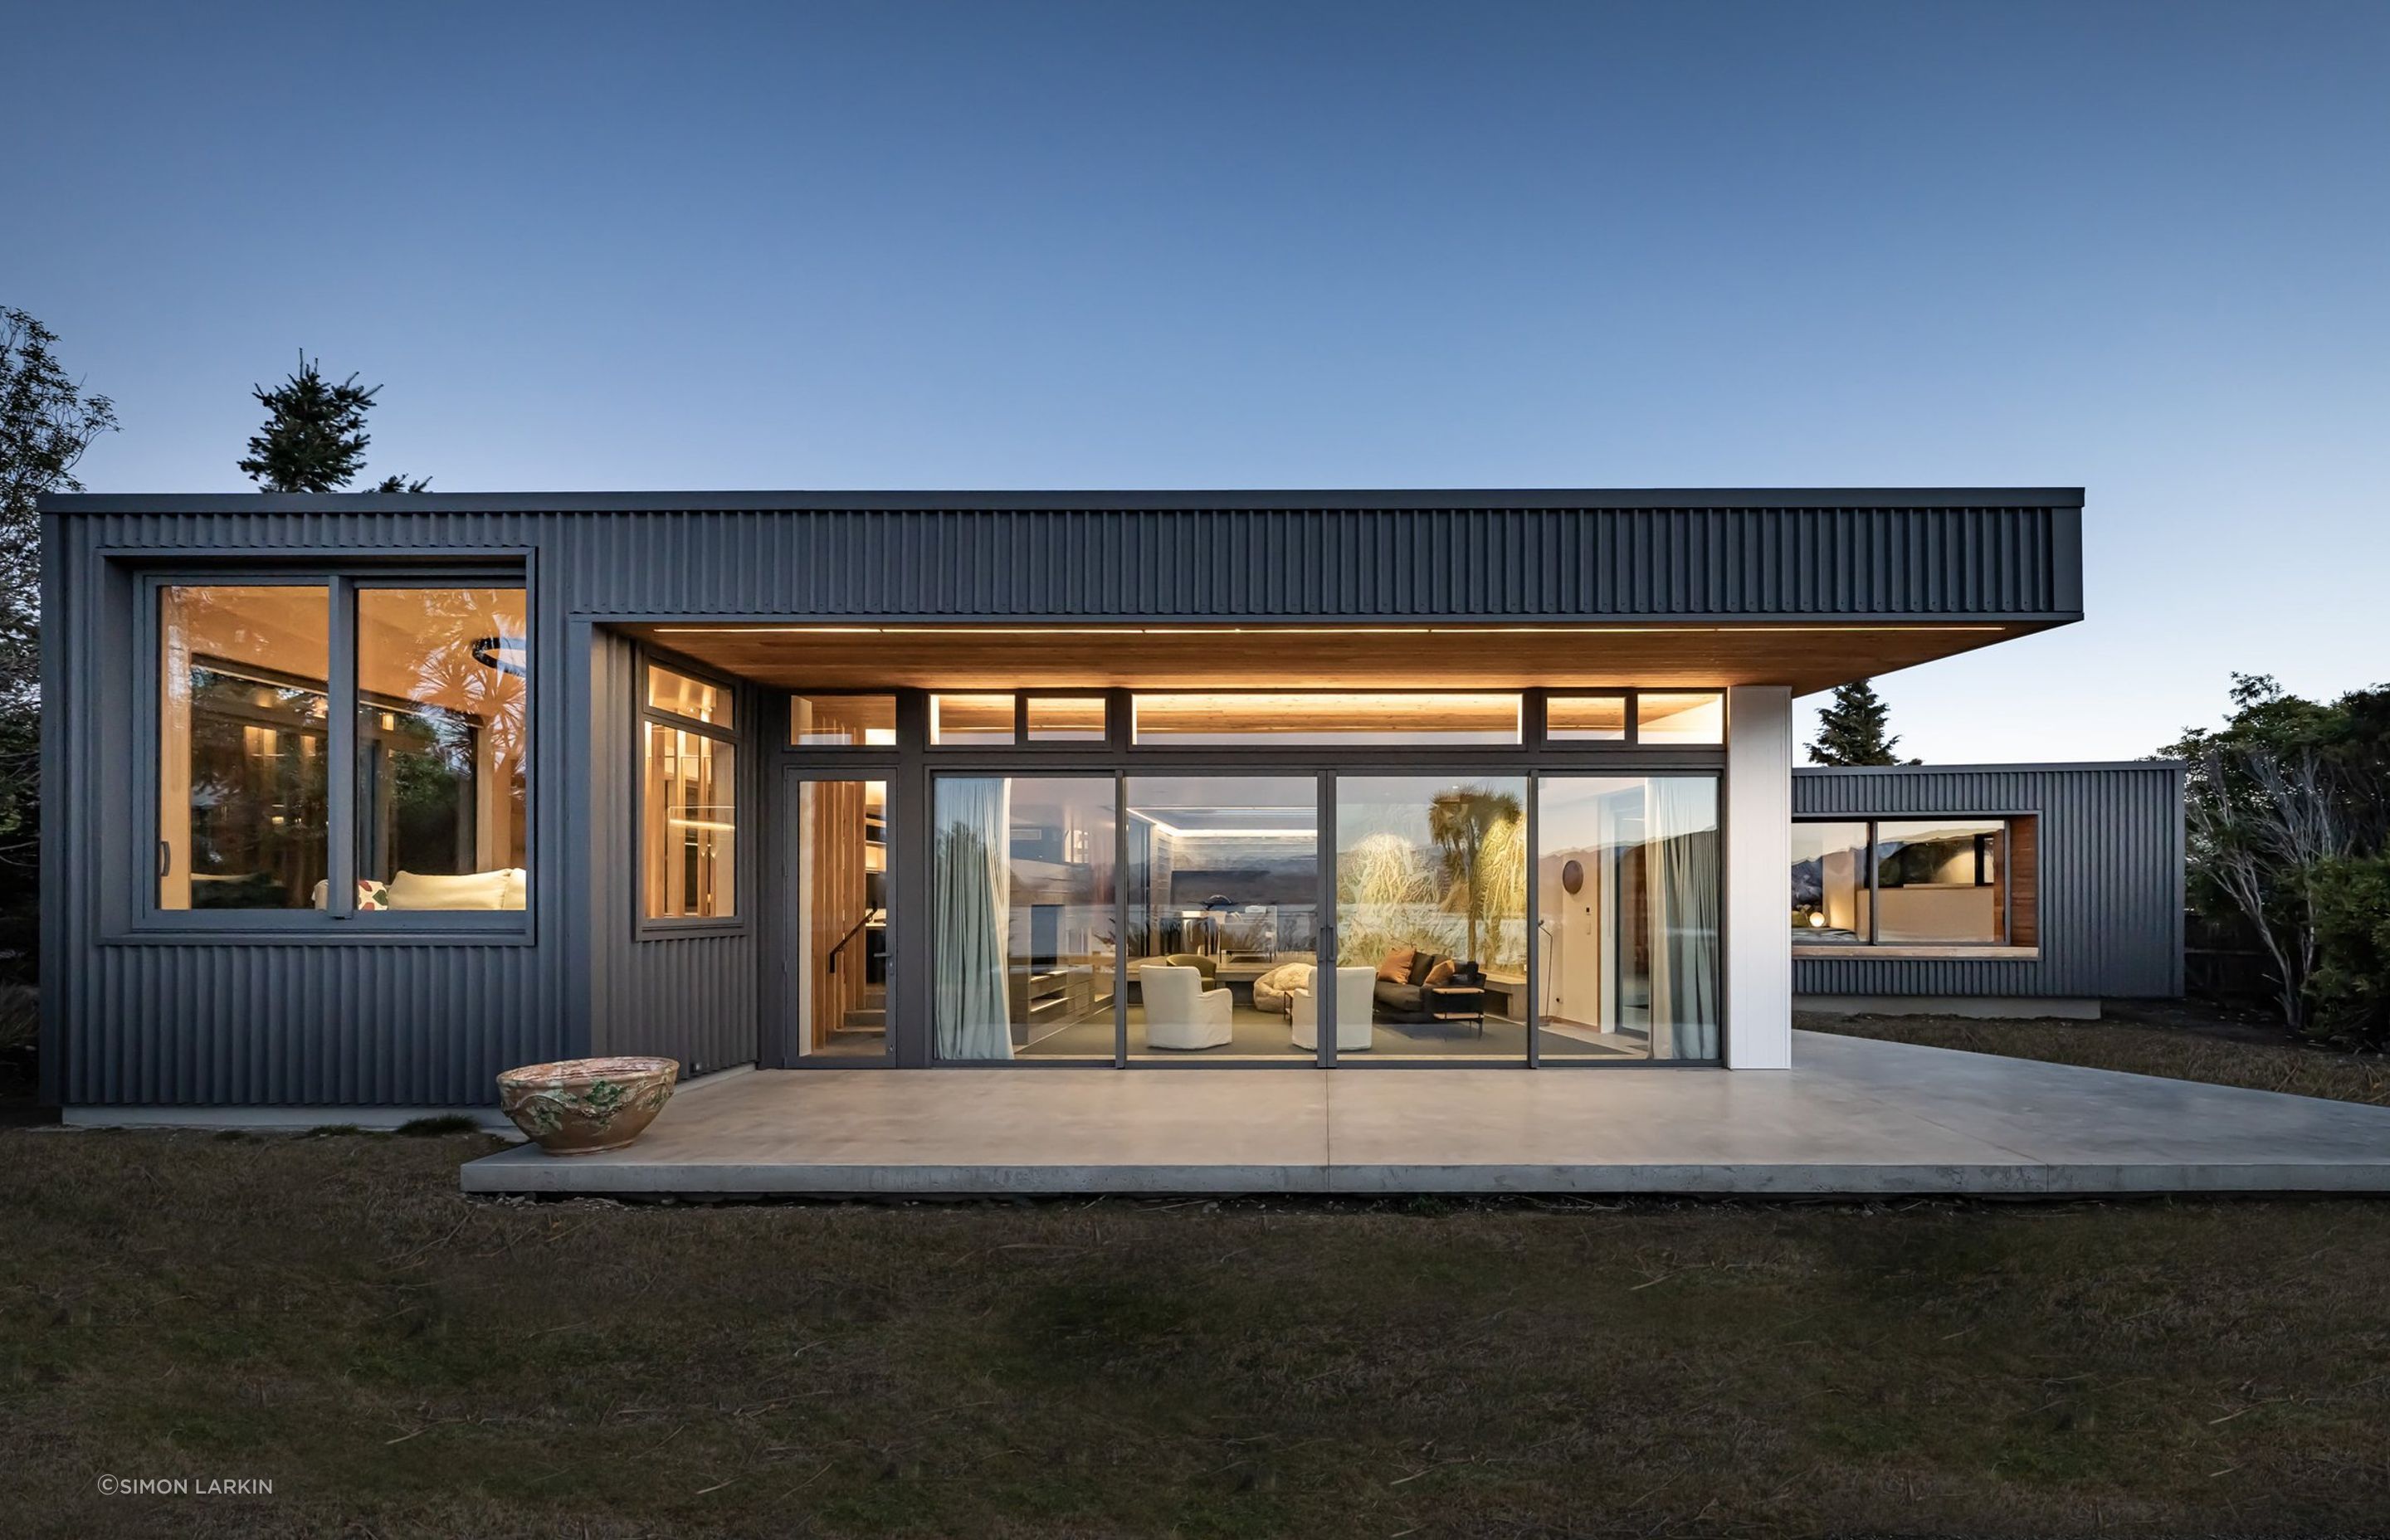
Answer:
41;488;2084;514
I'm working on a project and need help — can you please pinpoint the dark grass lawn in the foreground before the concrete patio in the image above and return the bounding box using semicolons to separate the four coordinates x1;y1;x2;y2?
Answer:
0;1128;2390;1538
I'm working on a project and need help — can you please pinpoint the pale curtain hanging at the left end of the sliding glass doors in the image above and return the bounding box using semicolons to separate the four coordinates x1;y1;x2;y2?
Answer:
932;777;1013;1060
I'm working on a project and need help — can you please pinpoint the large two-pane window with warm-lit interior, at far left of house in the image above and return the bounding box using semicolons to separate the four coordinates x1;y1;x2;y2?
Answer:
155;577;530;916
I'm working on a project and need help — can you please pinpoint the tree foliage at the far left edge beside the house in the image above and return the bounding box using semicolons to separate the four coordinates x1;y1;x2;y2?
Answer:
0;306;117;978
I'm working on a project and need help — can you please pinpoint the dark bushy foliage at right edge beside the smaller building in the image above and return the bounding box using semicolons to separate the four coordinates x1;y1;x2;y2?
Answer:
2168;675;2390;1047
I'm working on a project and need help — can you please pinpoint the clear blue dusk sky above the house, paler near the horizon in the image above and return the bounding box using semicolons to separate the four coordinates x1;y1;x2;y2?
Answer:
0;0;2390;760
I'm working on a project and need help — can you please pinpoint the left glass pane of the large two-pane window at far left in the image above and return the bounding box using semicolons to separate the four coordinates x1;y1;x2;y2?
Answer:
158;583;332;909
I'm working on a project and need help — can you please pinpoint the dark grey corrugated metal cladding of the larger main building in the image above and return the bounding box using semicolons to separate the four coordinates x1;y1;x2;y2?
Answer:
43;488;2081;1104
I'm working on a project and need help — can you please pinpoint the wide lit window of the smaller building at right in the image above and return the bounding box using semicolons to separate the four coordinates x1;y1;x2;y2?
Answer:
1792;816;2039;947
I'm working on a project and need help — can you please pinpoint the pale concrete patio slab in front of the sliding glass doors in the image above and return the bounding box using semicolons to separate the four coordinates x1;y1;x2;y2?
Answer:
461;1033;2390;1196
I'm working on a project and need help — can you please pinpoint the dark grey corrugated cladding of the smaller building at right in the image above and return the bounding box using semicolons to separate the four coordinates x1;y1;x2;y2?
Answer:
1792;760;2182;1000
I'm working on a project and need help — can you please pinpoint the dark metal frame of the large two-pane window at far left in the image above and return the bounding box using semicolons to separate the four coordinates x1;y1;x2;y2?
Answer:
127;564;545;944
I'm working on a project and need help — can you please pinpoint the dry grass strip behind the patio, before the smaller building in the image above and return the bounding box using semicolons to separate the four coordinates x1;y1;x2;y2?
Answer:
1800;1016;2390;1107
